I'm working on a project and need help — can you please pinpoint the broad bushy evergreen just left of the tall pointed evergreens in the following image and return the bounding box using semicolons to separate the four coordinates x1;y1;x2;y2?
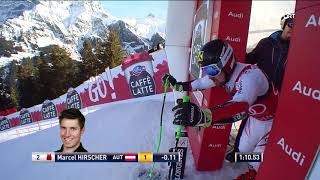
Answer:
37;45;82;101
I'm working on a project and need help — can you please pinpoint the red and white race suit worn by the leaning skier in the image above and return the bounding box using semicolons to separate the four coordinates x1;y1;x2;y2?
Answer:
191;63;278;170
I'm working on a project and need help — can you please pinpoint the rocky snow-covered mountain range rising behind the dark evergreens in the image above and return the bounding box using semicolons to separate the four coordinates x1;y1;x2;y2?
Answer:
0;1;165;66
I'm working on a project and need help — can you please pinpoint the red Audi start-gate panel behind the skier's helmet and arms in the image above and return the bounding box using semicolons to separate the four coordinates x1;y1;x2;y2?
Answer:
188;0;251;171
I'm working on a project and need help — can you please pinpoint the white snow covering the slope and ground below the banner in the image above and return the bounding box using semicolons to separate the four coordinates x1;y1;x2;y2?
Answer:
0;93;247;180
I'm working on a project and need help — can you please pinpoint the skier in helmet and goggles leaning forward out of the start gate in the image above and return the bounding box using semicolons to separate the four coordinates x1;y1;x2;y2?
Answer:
163;39;277;178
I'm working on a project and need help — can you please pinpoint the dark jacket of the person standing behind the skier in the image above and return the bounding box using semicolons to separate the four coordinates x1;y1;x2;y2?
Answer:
246;31;290;90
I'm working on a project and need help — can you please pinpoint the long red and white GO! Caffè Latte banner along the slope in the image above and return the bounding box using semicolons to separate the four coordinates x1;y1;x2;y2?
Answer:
0;49;171;131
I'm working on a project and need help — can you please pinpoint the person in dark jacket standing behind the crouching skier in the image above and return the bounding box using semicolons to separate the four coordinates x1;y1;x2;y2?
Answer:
226;13;295;166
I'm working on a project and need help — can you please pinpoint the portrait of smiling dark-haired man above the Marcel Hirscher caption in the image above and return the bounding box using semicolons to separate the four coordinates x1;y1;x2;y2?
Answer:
56;108;88;153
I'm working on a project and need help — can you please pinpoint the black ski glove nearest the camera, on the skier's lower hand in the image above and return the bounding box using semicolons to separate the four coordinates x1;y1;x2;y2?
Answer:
172;102;212;128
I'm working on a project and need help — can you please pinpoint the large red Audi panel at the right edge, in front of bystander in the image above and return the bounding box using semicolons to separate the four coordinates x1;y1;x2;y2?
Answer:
257;0;320;180
